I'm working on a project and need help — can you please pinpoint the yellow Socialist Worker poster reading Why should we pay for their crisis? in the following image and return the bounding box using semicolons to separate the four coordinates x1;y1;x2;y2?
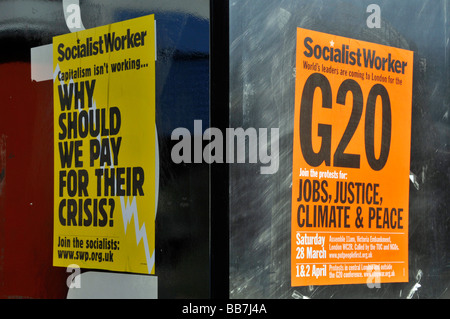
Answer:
53;15;156;274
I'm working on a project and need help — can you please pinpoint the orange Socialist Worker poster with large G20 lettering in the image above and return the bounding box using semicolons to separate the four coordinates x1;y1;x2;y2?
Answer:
291;28;413;286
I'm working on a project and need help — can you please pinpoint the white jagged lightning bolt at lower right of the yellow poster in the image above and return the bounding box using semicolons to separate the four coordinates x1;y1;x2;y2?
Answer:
120;196;155;274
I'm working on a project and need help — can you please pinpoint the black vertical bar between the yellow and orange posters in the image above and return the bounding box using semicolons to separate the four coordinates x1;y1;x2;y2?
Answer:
210;0;229;299
